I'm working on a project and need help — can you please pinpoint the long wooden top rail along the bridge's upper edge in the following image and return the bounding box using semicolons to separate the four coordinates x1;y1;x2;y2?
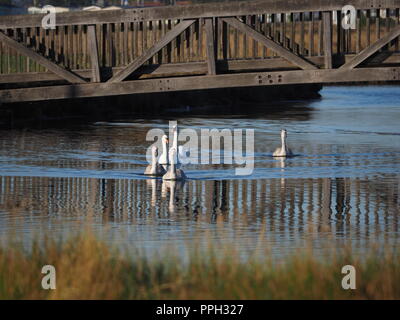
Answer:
0;0;400;29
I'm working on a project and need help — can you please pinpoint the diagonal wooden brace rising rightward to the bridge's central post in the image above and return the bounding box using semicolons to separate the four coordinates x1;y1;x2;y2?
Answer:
108;20;195;83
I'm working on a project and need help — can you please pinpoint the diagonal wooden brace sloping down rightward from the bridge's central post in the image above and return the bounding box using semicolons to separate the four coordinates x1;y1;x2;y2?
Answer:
222;18;318;70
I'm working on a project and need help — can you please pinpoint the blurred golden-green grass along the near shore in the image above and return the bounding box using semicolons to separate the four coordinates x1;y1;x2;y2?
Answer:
0;232;400;300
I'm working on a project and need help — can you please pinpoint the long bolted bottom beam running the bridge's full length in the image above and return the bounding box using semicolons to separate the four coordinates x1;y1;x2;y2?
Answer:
0;67;400;103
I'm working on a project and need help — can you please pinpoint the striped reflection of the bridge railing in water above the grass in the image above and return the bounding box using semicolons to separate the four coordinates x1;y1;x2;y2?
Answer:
0;177;400;252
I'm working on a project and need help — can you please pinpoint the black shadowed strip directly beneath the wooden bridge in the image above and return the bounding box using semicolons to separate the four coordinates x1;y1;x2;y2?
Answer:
0;85;321;128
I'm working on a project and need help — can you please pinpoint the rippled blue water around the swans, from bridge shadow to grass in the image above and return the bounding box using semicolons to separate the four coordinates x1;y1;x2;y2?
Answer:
0;86;400;255
